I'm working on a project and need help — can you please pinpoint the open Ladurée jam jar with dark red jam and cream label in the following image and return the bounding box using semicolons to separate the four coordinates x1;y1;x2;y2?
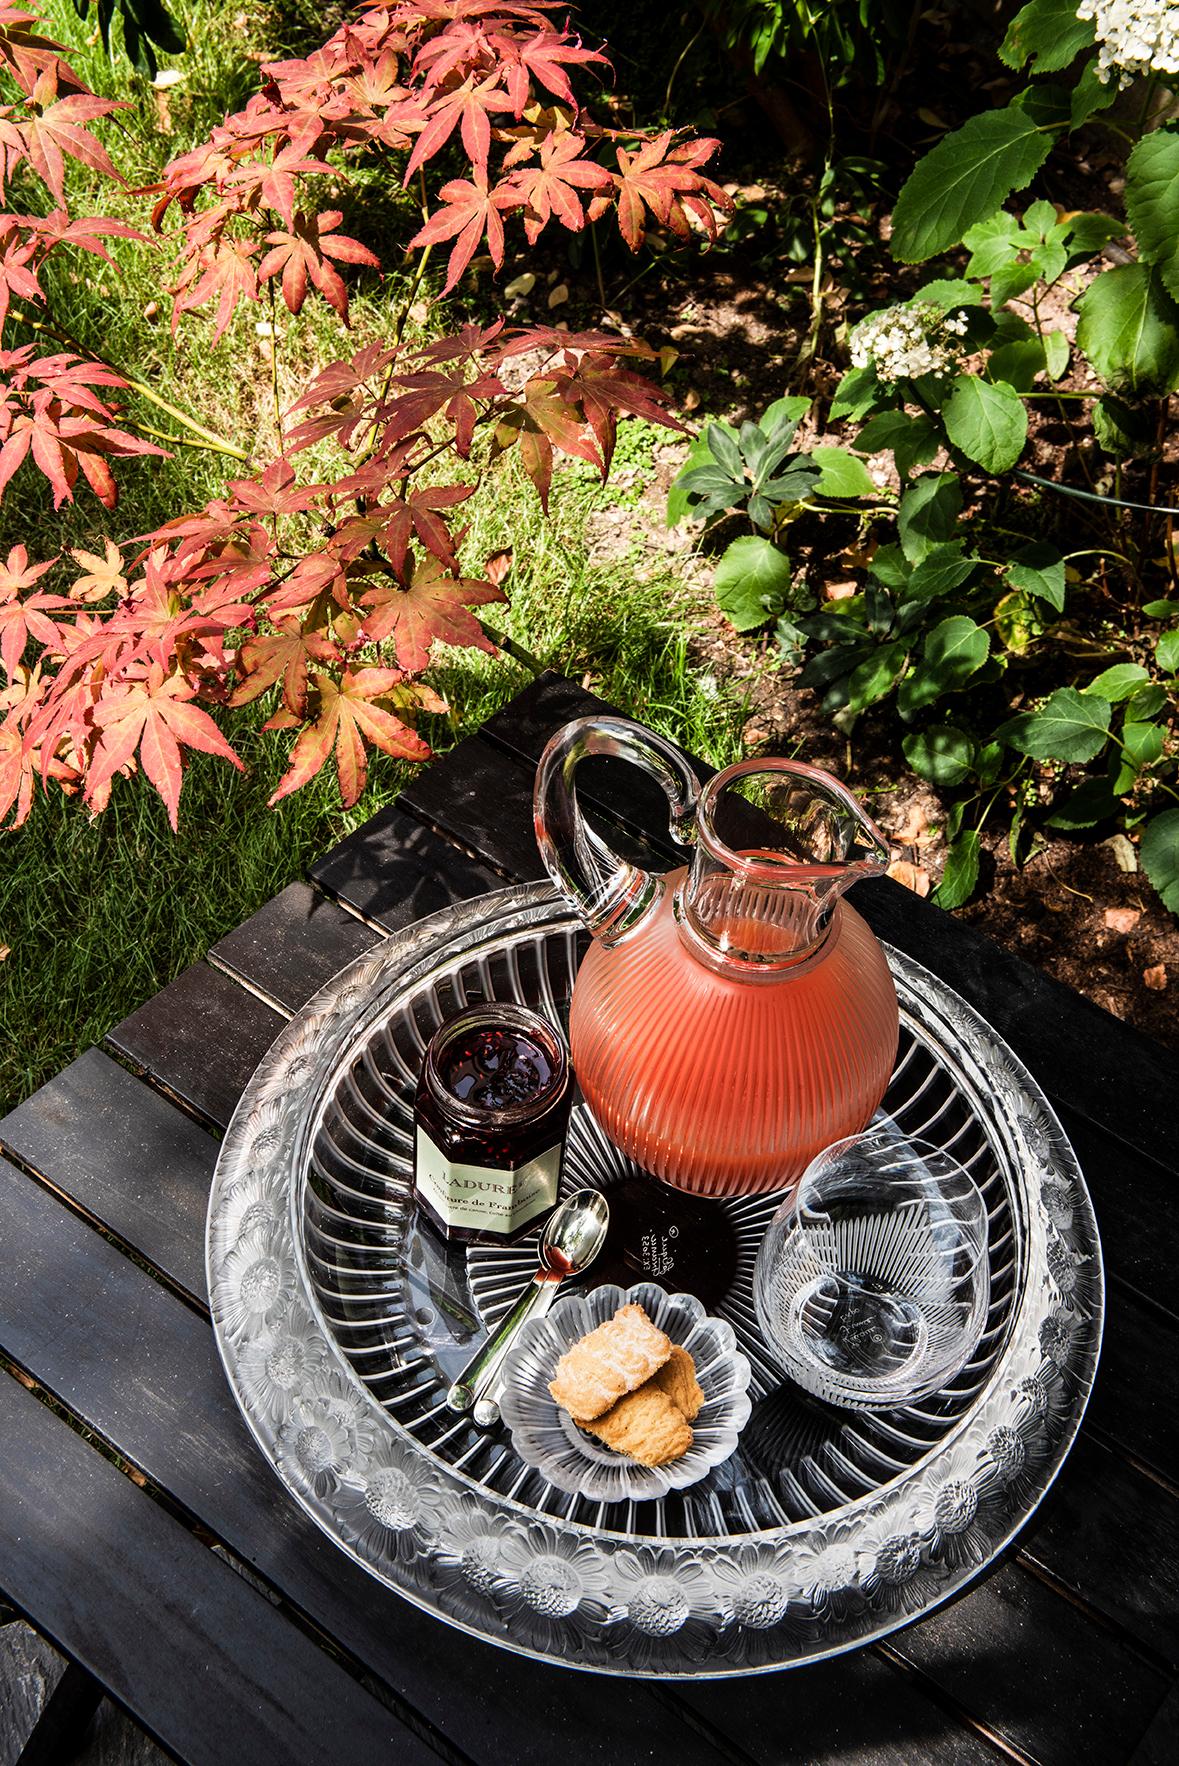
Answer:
413;1001;574;1241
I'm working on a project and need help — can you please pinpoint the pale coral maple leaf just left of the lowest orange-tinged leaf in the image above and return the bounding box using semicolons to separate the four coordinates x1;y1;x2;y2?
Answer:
85;668;242;832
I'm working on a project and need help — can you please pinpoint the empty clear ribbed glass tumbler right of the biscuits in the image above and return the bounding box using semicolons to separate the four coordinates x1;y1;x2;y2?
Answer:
754;1127;990;1409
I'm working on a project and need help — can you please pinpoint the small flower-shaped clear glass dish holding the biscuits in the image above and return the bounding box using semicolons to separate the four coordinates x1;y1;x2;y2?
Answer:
499;1282;750;1503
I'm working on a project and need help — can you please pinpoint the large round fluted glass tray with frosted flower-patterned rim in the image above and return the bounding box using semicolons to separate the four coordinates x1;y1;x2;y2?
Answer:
207;885;1103;1676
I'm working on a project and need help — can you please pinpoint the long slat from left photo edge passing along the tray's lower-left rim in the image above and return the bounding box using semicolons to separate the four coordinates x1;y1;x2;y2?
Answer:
0;1160;755;1766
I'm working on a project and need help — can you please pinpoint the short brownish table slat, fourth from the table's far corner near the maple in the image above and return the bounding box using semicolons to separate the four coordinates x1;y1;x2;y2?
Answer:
208;883;379;1012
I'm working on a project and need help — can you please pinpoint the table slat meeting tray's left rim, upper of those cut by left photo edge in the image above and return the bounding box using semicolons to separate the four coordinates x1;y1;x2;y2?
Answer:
0;1049;217;1300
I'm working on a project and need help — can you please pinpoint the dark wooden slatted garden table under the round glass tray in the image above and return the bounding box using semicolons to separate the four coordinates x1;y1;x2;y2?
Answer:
0;676;1179;1766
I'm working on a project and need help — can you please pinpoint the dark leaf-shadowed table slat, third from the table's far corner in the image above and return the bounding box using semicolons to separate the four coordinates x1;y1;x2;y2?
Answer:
311;805;505;932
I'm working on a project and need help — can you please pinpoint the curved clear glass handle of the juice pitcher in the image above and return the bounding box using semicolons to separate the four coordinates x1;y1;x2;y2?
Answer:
533;717;701;945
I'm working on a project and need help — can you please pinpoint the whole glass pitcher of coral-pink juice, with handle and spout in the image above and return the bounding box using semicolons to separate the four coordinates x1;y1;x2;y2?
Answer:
535;717;898;1196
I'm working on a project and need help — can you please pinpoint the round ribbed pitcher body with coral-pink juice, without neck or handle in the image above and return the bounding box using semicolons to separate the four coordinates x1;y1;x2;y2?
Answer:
570;871;898;1196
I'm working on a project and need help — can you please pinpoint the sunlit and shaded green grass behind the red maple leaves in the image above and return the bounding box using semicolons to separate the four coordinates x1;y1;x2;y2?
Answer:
0;0;740;1113
